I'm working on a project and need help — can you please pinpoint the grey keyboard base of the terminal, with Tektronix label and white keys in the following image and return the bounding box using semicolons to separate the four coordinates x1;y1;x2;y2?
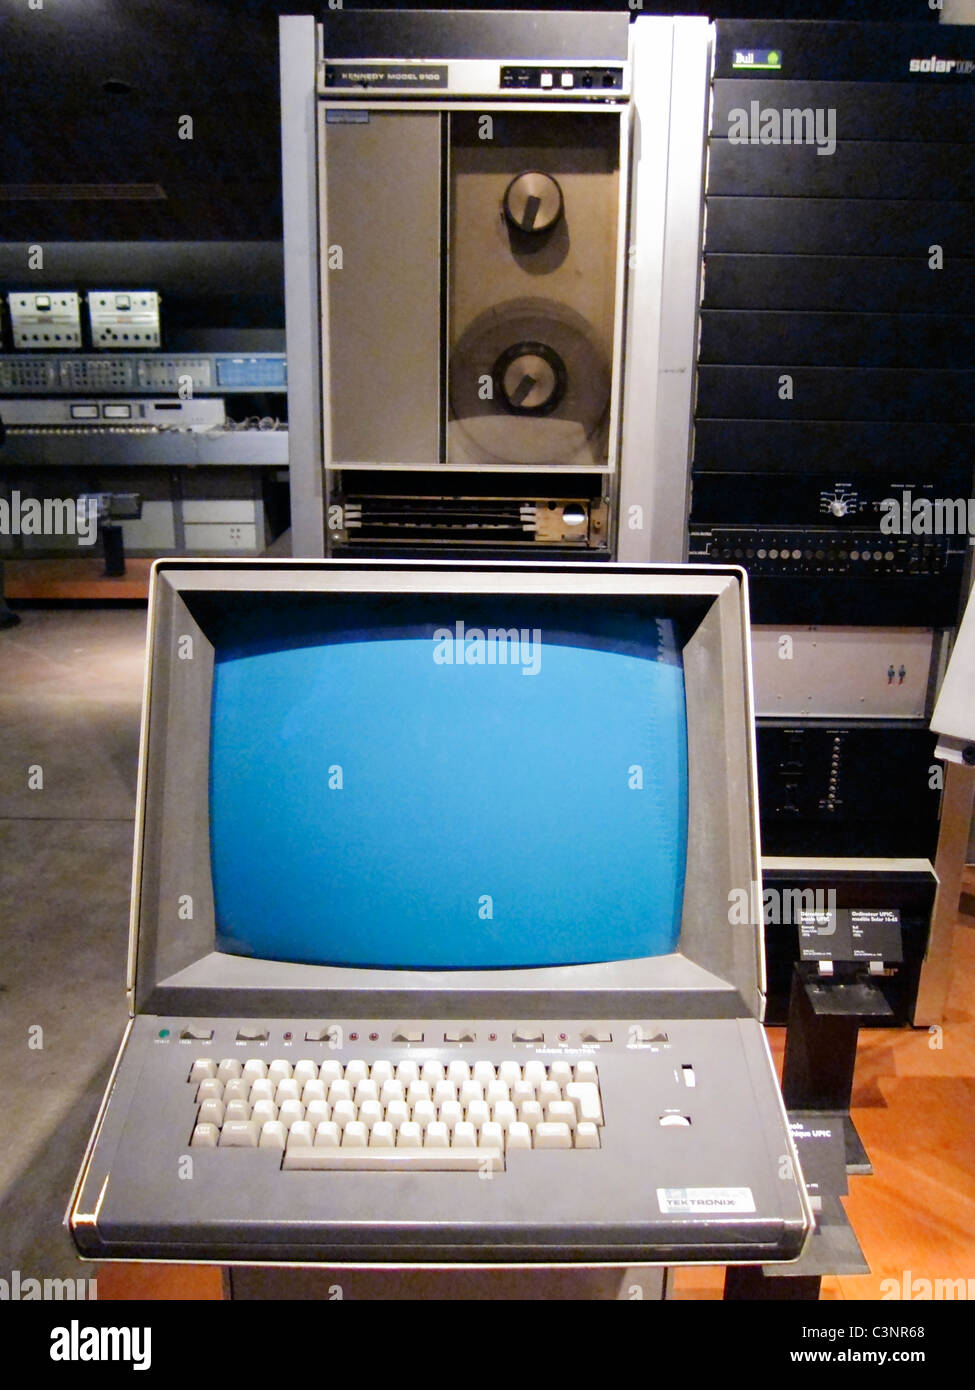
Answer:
71;1015;808;1265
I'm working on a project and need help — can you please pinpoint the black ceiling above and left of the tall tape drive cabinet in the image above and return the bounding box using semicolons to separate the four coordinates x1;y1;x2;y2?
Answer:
0;0;937;242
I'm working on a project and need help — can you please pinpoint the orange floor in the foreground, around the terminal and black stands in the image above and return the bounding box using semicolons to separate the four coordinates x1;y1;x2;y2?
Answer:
97;869;975;1300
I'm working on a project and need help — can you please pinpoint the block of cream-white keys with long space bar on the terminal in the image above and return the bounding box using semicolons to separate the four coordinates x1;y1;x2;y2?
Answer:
188;1056;602;1172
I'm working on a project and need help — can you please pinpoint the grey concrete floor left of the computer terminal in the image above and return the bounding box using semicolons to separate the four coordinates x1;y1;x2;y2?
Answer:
0;605;146;1279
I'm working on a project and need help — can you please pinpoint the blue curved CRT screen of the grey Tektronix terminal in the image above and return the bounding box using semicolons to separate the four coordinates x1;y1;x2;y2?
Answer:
210;595;687;969
